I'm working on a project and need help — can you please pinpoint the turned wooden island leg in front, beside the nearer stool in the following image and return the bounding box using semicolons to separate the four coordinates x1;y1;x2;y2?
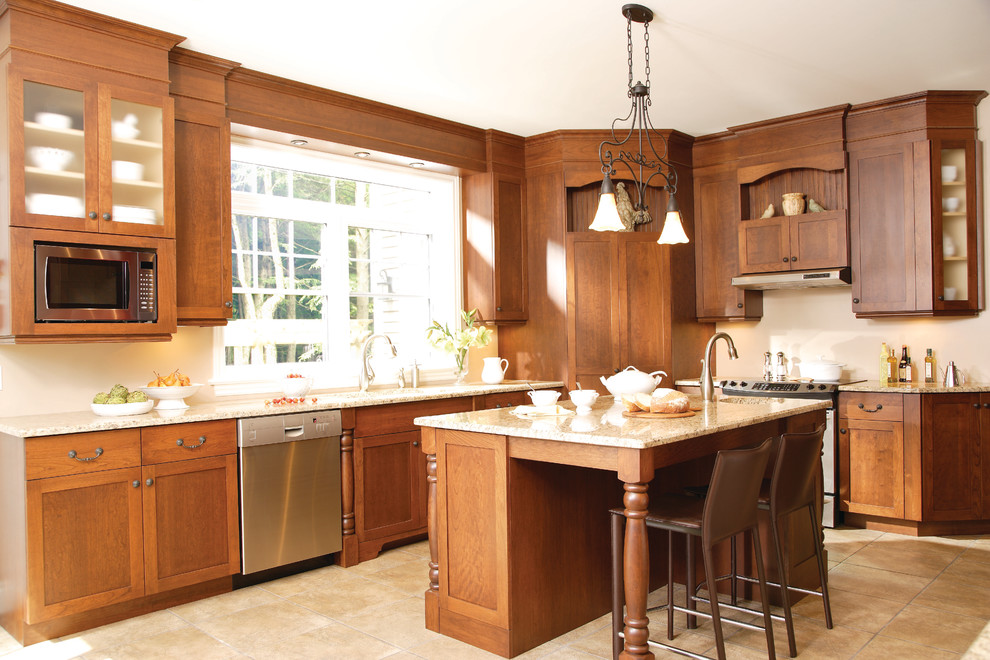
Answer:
619;483;654;660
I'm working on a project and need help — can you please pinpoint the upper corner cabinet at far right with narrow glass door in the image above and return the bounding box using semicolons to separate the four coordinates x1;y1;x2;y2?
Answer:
847;91;986;318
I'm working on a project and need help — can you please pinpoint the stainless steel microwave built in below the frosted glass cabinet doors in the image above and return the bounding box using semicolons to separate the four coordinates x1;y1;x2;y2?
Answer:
34;242;158;323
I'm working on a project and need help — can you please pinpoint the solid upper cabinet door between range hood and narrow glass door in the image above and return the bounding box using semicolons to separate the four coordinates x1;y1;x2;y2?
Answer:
849;144;931;316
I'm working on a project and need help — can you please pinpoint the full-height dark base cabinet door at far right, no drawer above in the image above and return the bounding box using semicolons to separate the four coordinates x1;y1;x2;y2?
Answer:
921;394;983;521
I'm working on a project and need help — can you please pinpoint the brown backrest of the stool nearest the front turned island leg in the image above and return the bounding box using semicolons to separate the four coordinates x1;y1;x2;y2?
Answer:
701;438;773;544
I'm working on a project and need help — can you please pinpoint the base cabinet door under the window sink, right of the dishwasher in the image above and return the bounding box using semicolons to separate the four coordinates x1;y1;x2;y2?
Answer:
354;430;426;541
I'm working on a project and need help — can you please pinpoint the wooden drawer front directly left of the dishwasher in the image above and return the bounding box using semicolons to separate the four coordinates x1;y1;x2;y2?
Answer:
141;419;237;465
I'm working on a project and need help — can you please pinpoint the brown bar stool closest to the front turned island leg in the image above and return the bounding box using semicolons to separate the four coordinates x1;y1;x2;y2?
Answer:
609;438;775;660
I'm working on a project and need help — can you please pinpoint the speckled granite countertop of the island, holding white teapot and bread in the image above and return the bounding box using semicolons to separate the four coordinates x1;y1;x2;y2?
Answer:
414;396;828;449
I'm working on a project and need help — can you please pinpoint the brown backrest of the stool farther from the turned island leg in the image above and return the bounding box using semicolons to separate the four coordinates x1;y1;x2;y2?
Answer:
770;424;825;516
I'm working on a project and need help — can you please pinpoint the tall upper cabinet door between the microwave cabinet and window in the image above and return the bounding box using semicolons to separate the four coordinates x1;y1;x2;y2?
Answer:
175;112;234;326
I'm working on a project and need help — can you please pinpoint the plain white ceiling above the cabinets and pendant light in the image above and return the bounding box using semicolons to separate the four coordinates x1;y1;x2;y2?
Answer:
63;0;990;136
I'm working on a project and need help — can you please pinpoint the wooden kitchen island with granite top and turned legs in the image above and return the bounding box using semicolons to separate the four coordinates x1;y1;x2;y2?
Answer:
415;397;826;658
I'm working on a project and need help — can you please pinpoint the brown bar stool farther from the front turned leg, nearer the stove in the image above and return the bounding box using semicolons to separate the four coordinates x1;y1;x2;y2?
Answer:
718;424;832;658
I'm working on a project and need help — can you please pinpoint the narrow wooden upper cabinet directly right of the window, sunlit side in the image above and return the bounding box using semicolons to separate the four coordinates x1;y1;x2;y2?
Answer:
463;130;528;324
